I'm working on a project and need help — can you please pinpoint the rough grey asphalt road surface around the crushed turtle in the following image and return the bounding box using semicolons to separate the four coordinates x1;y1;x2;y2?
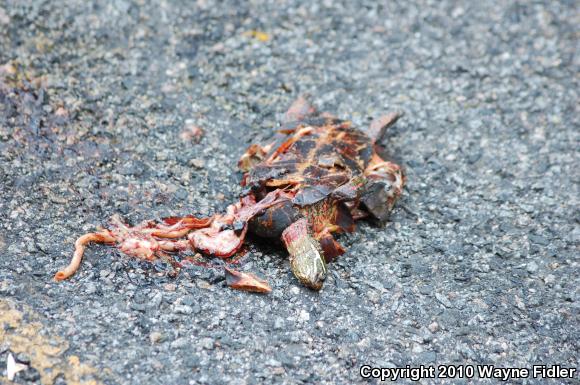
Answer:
0;0;580;384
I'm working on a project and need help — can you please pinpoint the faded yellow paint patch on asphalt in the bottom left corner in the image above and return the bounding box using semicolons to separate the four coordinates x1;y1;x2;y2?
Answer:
0;299;101;385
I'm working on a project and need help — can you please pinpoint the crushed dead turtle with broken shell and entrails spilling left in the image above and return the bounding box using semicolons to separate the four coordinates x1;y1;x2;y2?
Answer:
55;97;405;292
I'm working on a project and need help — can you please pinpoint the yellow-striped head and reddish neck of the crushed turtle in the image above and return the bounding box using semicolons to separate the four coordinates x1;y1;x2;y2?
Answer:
282;218;326;290
